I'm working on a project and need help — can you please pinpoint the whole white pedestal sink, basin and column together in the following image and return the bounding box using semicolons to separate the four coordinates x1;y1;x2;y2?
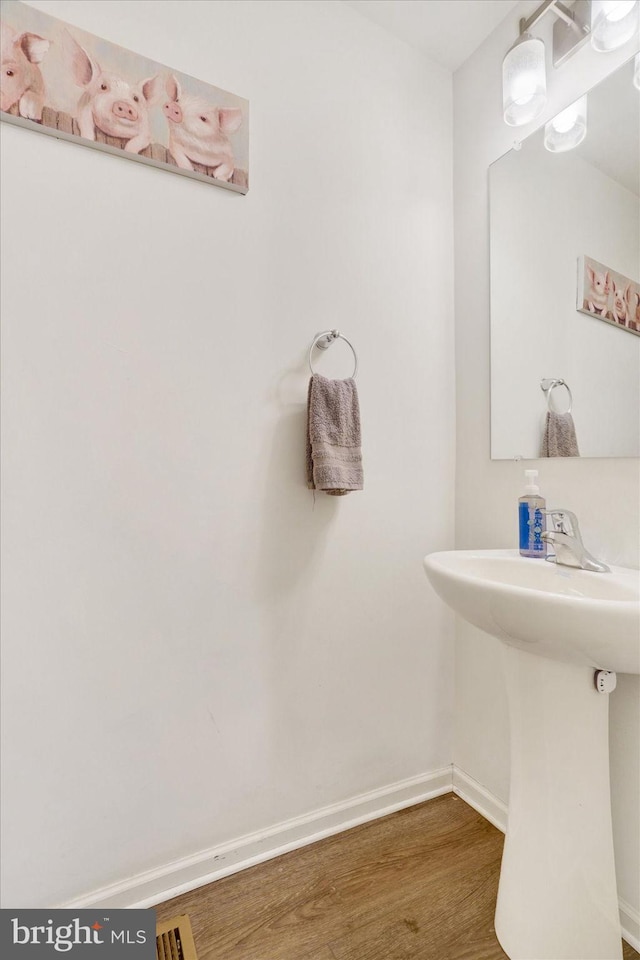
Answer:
424;550;640;960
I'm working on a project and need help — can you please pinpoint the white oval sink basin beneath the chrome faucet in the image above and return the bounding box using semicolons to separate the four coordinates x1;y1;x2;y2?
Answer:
424;550;640;673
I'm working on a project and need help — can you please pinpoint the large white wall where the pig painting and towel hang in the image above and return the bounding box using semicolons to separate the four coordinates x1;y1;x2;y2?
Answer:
2;0;455;907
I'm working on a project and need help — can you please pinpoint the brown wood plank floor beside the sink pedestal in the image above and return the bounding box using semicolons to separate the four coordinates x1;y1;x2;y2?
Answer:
156;794;639;960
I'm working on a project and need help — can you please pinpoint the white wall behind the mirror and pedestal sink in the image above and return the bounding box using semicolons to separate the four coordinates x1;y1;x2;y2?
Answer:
454;2;640;910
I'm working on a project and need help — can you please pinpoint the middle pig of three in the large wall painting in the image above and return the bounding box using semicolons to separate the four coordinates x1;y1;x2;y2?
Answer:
65;32;161;153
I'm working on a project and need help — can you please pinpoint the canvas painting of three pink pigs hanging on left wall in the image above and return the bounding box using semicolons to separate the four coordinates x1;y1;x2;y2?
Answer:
0;0;249;193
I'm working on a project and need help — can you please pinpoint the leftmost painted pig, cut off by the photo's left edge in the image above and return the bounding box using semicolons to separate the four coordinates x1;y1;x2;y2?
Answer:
0;23;50;122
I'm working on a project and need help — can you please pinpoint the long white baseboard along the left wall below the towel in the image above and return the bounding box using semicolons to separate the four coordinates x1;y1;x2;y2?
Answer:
60;765;452;909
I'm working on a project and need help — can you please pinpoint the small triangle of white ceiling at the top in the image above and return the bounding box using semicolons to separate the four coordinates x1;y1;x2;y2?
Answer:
344;0;519;70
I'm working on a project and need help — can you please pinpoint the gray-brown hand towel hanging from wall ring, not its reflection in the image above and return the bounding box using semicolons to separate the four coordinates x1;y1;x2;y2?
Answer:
307;373;364;497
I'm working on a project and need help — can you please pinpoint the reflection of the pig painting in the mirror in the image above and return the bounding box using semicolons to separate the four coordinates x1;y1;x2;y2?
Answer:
577;257;640;336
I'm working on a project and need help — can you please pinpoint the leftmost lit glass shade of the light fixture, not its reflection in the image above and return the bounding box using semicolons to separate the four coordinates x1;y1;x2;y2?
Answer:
502;33;547;127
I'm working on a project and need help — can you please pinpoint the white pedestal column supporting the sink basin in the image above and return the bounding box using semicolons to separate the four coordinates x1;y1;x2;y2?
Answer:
495;643;622;960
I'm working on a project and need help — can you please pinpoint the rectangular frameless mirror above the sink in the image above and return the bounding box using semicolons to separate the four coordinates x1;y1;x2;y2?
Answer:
489;60;640;460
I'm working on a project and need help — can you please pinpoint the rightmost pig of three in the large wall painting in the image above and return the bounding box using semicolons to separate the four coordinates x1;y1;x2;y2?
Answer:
163;76;242;181
